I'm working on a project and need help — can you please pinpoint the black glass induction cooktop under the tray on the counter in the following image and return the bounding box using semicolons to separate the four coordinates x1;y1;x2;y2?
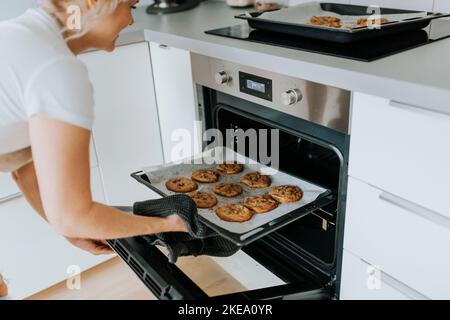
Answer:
206;19;450;62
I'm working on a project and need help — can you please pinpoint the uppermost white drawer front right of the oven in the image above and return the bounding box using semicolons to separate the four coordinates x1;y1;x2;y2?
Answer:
349;93;450;217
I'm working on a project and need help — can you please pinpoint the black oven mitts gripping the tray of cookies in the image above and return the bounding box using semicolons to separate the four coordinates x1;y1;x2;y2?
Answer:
133;194;239;263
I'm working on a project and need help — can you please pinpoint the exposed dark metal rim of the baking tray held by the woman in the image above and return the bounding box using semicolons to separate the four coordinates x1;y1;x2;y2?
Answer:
131;171;336;247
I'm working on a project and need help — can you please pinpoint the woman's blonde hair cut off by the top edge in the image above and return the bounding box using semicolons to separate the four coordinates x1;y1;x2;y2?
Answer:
41;0;128;41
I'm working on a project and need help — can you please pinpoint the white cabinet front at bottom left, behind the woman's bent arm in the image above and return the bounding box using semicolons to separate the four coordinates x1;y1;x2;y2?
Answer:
0;169;112;299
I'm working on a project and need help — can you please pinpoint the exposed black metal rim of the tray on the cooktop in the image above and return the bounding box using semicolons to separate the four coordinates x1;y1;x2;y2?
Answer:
235;3;450;43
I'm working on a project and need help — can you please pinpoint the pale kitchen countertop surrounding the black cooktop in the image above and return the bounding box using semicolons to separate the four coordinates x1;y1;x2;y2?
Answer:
119;0;450;114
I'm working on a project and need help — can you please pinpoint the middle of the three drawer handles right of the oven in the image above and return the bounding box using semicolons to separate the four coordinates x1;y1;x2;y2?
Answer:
379;192;450;229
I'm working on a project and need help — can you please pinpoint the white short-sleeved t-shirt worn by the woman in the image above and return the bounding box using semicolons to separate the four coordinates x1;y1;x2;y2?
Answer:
0;9;94;154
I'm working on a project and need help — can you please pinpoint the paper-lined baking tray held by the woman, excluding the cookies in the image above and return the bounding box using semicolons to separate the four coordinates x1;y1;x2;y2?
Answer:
132;148;336;247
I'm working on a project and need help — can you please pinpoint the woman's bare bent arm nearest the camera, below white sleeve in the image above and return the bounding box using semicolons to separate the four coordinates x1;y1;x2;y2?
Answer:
30;116;186;239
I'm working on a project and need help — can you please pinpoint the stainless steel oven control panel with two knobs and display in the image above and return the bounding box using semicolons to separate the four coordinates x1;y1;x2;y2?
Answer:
192;54;350;133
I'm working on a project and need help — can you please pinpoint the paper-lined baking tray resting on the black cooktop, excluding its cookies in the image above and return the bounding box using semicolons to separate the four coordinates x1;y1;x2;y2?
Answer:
235;2;450;43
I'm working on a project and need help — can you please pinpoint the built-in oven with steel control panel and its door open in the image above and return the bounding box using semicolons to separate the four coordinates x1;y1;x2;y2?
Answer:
110;54;350;300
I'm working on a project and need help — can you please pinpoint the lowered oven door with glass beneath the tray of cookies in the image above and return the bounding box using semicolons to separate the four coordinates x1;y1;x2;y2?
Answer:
109;237;333;300
